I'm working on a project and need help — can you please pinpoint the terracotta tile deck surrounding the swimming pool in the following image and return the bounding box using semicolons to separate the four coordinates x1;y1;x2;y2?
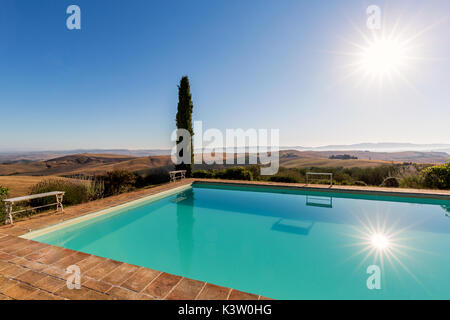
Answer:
0;179;450;300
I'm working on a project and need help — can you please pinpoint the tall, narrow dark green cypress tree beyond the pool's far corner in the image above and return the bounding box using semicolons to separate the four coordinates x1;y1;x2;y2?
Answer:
175;76;194;177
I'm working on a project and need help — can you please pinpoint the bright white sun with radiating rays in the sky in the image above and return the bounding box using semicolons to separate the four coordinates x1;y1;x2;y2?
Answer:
331;9;445;93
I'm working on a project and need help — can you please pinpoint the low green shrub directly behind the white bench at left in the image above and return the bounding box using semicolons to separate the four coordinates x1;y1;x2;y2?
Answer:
30;179;89;207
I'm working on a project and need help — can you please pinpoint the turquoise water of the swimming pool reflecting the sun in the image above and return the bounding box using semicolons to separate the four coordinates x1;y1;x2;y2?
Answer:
30;184;450;299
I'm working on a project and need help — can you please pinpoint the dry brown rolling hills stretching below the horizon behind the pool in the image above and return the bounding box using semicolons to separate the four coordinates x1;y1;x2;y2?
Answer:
0;150;450;176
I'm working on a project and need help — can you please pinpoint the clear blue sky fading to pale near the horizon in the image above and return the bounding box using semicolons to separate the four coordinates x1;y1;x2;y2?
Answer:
0;0;450;151
